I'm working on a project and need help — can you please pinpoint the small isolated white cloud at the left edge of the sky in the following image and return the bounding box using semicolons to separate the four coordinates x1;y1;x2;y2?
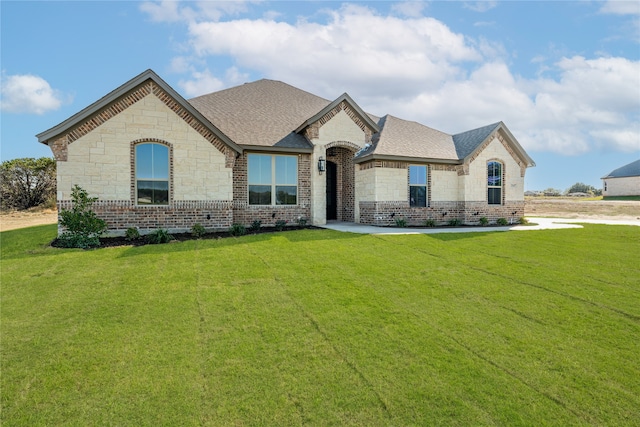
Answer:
0;74;63;114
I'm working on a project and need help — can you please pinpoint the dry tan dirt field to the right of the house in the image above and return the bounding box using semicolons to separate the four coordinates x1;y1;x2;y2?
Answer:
524;197;640;220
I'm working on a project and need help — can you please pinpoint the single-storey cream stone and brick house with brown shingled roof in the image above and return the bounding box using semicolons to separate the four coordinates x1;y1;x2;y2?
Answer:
37;70;534;234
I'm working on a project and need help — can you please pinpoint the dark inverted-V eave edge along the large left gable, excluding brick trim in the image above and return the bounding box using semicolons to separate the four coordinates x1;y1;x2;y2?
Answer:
36;69;242;154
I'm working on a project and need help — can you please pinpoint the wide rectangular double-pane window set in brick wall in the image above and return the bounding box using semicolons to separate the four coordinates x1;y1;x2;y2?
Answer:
247;154;298;205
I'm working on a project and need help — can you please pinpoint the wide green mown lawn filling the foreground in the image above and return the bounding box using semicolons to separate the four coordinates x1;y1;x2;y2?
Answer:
0;225;640;426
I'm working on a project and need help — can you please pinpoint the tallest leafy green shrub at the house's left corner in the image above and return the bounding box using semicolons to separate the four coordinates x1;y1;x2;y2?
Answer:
58;185;107;249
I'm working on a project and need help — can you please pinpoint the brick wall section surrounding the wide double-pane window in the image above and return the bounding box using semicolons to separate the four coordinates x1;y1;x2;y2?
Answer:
233;152;311;226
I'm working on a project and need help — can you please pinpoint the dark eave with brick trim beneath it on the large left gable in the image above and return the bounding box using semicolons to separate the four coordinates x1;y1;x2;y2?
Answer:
36;70;242;165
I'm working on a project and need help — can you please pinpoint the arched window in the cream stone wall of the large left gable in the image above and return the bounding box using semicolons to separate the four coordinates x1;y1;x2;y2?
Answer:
135;144;169;205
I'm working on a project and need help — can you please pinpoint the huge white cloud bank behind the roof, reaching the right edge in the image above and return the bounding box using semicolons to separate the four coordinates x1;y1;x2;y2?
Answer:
144;3;640;154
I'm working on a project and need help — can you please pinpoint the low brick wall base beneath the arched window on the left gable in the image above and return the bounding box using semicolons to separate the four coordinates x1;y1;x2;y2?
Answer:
57;200;233;236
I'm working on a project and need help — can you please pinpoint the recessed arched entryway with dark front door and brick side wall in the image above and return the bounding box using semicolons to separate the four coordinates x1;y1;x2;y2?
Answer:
326;143;358;222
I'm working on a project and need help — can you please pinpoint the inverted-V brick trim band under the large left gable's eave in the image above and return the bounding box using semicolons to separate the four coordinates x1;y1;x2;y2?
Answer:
49;80;235;168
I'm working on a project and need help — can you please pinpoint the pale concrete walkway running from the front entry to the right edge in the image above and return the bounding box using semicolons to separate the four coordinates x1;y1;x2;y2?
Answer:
320;217;640;234
